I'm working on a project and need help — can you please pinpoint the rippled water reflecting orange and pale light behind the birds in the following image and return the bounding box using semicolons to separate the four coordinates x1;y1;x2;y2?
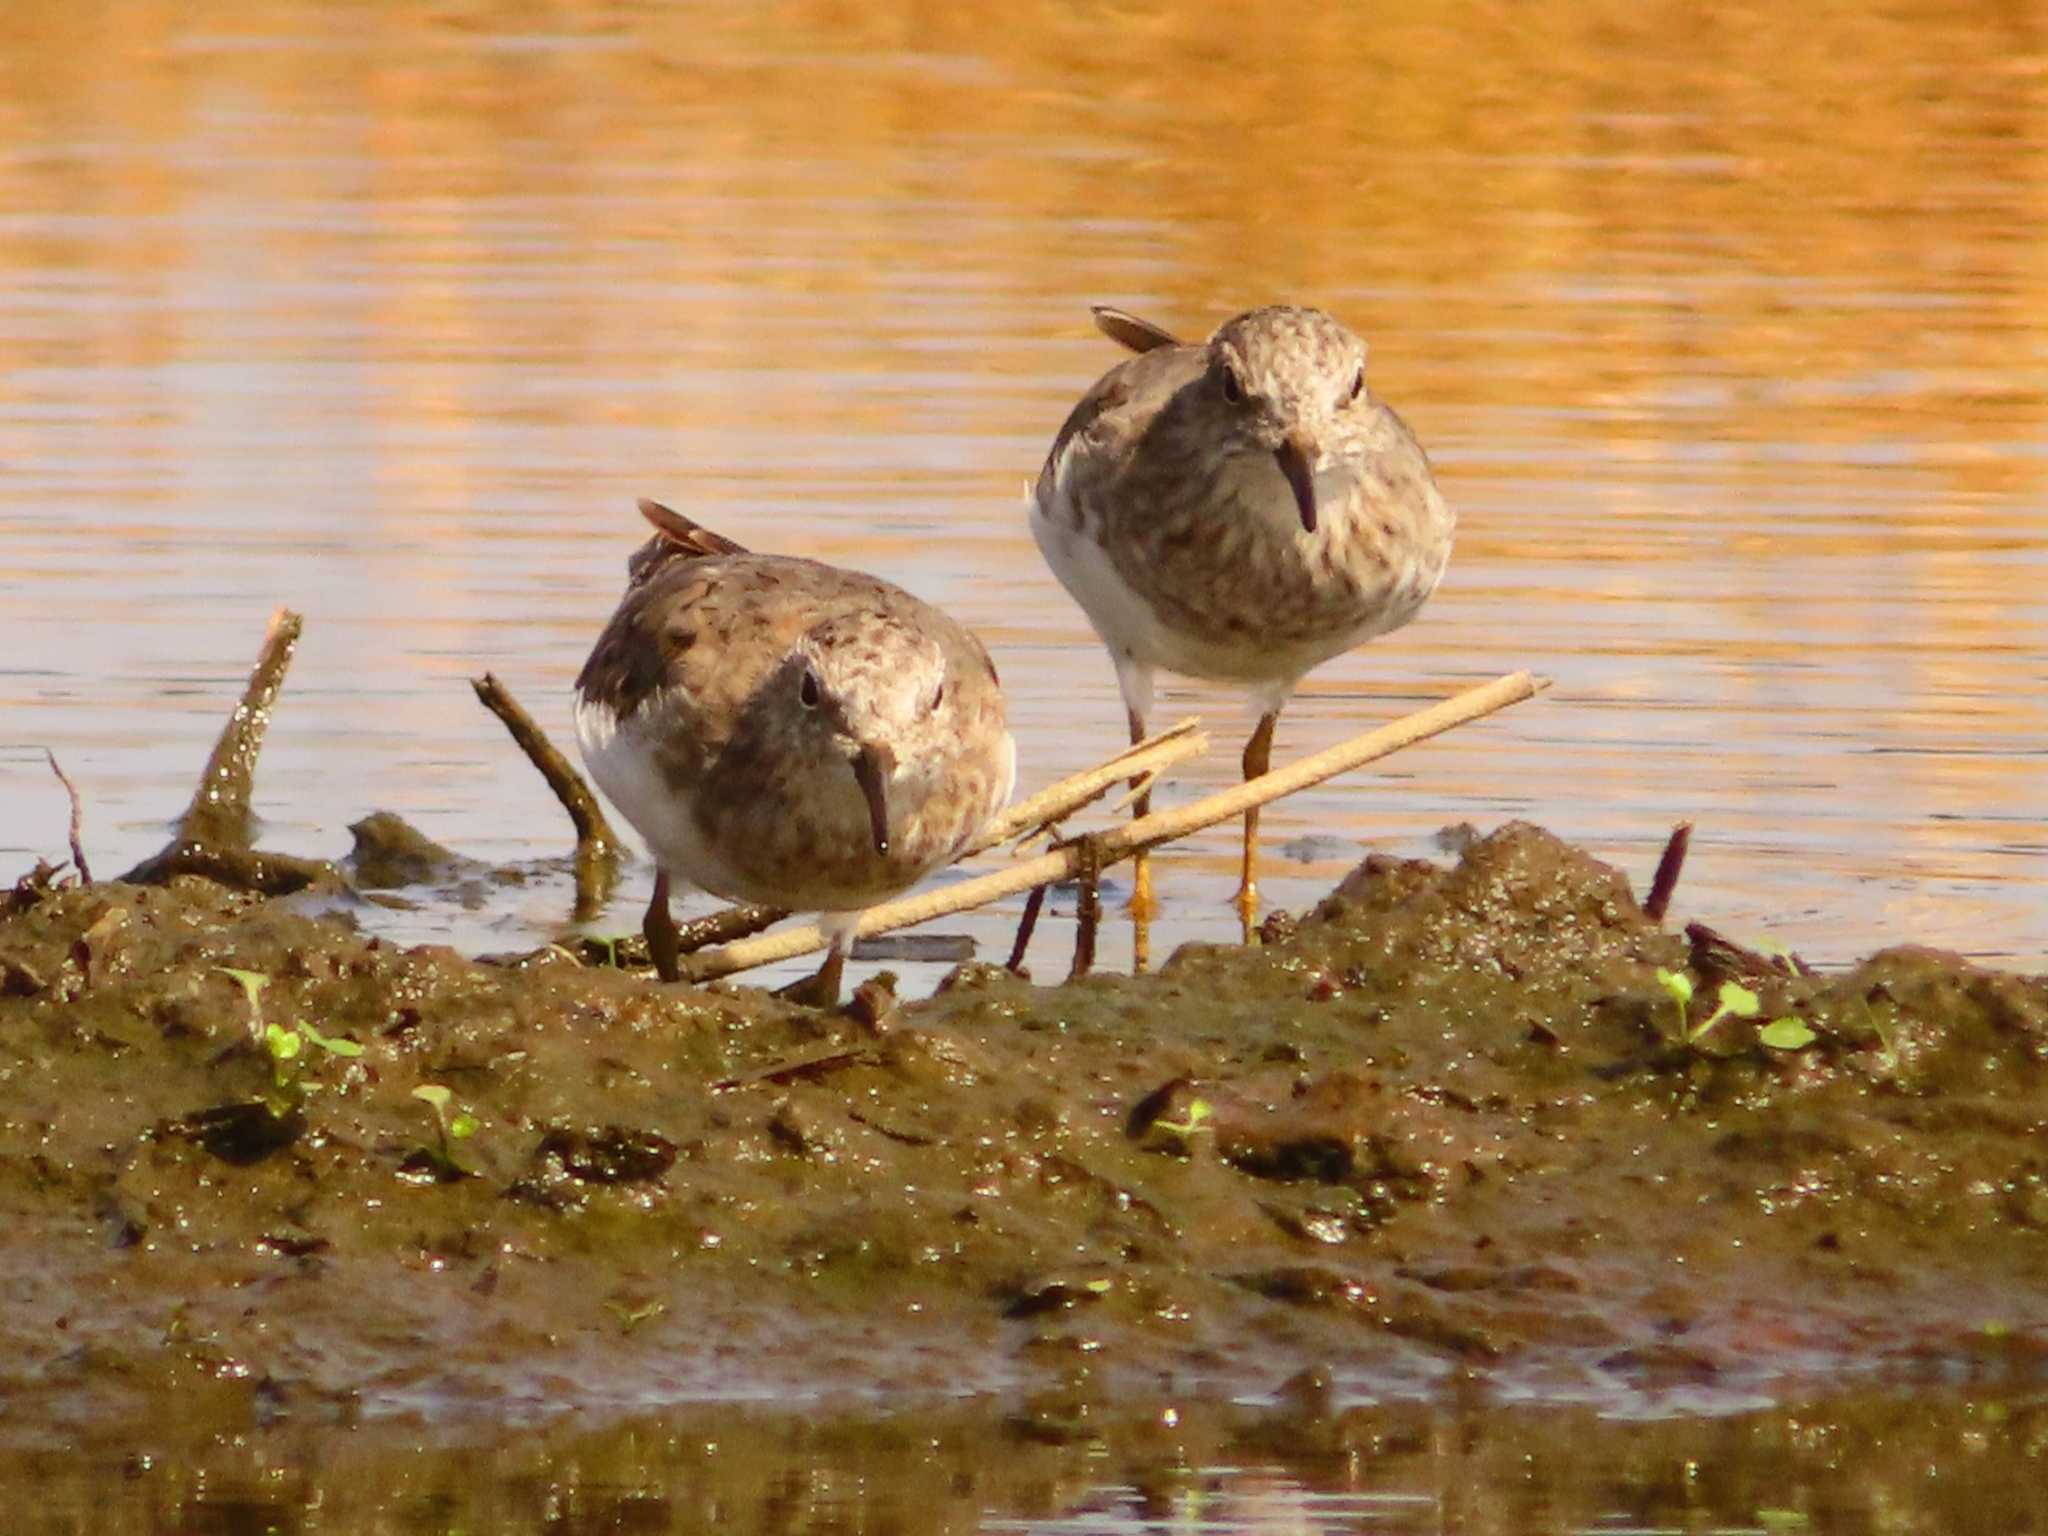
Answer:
0;0;2048;999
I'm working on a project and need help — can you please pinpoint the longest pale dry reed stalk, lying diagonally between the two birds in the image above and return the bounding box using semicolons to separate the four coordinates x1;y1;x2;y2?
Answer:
682;672;1550;981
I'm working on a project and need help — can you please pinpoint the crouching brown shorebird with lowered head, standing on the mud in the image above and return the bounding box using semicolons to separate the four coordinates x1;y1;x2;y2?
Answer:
575;502;1016;1006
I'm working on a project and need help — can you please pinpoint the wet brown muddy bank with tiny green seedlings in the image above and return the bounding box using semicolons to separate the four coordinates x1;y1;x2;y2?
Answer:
0;825;2048;1436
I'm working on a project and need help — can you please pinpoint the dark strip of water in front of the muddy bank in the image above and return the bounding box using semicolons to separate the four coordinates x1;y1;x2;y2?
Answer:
19;1393;2048;1536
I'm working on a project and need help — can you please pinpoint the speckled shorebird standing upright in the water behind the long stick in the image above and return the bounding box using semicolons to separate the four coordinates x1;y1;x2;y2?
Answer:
1030;305;1454;942
